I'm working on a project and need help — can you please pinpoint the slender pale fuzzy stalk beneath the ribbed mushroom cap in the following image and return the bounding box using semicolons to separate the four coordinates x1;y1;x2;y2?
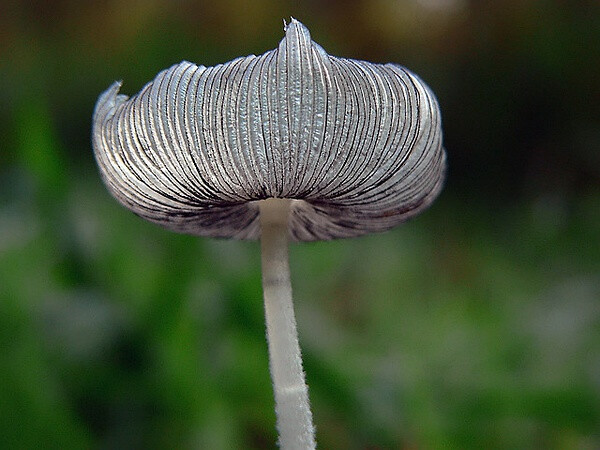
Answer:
259;198;316;450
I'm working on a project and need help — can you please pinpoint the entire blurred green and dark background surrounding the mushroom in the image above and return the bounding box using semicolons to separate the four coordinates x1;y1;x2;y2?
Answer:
0;0;600;449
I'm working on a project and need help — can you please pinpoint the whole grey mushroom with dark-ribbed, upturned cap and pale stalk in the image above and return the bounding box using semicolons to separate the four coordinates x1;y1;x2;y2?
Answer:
92;19;446;449
